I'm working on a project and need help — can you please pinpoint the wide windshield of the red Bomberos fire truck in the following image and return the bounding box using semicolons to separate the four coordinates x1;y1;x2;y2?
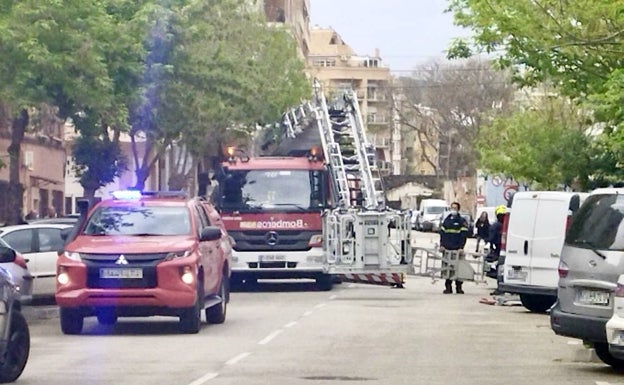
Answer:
220;170;326;211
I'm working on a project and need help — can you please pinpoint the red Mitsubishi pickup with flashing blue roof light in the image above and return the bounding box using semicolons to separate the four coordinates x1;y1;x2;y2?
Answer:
55;191;232;334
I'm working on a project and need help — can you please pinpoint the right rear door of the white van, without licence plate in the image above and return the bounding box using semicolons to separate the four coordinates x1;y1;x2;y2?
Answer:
528;192;572;288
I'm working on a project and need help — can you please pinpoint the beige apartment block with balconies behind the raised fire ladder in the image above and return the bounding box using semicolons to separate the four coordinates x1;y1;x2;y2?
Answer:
307;27;394;175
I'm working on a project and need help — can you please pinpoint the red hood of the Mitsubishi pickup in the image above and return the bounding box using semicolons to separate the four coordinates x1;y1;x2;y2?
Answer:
65;235;195;254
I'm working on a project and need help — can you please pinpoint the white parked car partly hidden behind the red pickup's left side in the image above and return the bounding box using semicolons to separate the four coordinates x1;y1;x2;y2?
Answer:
0;224;72;297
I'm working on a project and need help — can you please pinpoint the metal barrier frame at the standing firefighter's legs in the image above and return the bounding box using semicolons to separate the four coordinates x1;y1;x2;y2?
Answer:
410;247;490;283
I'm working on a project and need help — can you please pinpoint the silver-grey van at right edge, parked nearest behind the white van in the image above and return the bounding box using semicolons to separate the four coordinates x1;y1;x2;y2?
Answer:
548;188;624;369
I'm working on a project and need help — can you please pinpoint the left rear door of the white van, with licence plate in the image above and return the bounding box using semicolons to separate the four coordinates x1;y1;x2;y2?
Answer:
504;193;538;284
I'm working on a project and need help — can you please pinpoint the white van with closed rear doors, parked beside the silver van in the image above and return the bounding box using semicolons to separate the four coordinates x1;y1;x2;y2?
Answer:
498;191;589;313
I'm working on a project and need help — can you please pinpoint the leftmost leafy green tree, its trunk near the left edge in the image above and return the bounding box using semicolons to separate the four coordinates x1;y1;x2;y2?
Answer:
0;0;119;223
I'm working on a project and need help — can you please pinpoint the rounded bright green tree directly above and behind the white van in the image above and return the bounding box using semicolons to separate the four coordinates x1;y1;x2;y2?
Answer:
475;90;597;190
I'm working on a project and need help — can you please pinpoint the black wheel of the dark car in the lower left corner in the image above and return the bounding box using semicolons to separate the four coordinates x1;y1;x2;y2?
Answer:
0;310;30;383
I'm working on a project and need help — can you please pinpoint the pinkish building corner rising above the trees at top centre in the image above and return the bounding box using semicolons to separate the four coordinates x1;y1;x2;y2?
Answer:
264;0;310;59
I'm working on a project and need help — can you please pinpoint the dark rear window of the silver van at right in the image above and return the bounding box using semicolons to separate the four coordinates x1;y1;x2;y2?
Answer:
566;194;624;250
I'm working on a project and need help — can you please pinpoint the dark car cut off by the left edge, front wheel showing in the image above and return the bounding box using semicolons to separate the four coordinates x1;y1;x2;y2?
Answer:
0;246;30;383
